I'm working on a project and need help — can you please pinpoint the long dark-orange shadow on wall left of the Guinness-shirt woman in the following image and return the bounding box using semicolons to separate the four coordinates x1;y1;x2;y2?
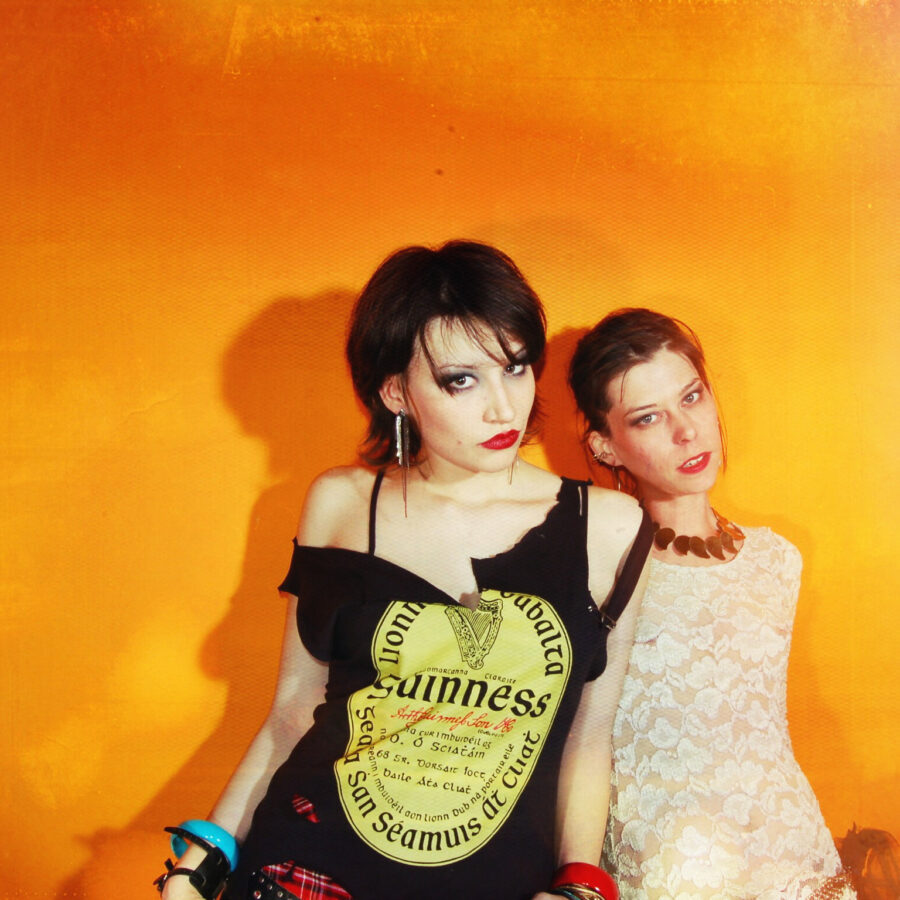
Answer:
56;291;365;900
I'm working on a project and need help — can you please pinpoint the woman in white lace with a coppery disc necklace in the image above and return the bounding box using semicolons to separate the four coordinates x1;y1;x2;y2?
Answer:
569;309;855;900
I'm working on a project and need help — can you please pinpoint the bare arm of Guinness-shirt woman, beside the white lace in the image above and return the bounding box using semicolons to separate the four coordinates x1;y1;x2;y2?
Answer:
539;489;648;896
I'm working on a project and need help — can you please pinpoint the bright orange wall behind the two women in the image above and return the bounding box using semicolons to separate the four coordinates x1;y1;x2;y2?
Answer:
0;0;900;898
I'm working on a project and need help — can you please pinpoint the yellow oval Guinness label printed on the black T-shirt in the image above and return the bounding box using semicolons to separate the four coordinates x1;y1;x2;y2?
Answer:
334;591;572;866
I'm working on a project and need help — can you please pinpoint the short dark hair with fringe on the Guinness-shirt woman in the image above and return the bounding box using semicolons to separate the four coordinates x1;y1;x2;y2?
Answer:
347;241;546;466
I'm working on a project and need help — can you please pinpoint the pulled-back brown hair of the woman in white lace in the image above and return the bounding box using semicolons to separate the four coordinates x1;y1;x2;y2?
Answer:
569;309;712;440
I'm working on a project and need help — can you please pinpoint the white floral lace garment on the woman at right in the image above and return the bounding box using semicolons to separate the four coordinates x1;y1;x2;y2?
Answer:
604;528;856;900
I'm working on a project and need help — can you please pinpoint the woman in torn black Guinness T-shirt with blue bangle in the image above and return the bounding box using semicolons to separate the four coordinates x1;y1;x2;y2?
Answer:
163;241;650;900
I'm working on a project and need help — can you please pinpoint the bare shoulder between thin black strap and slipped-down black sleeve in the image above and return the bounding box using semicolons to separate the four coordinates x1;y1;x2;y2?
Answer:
297;466;375;549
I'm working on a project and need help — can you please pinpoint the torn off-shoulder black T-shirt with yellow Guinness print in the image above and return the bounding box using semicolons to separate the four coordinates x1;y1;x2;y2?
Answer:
226;474;651;900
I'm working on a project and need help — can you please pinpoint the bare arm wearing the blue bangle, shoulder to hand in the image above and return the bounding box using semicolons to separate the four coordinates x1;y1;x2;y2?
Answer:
163;472;352;900
